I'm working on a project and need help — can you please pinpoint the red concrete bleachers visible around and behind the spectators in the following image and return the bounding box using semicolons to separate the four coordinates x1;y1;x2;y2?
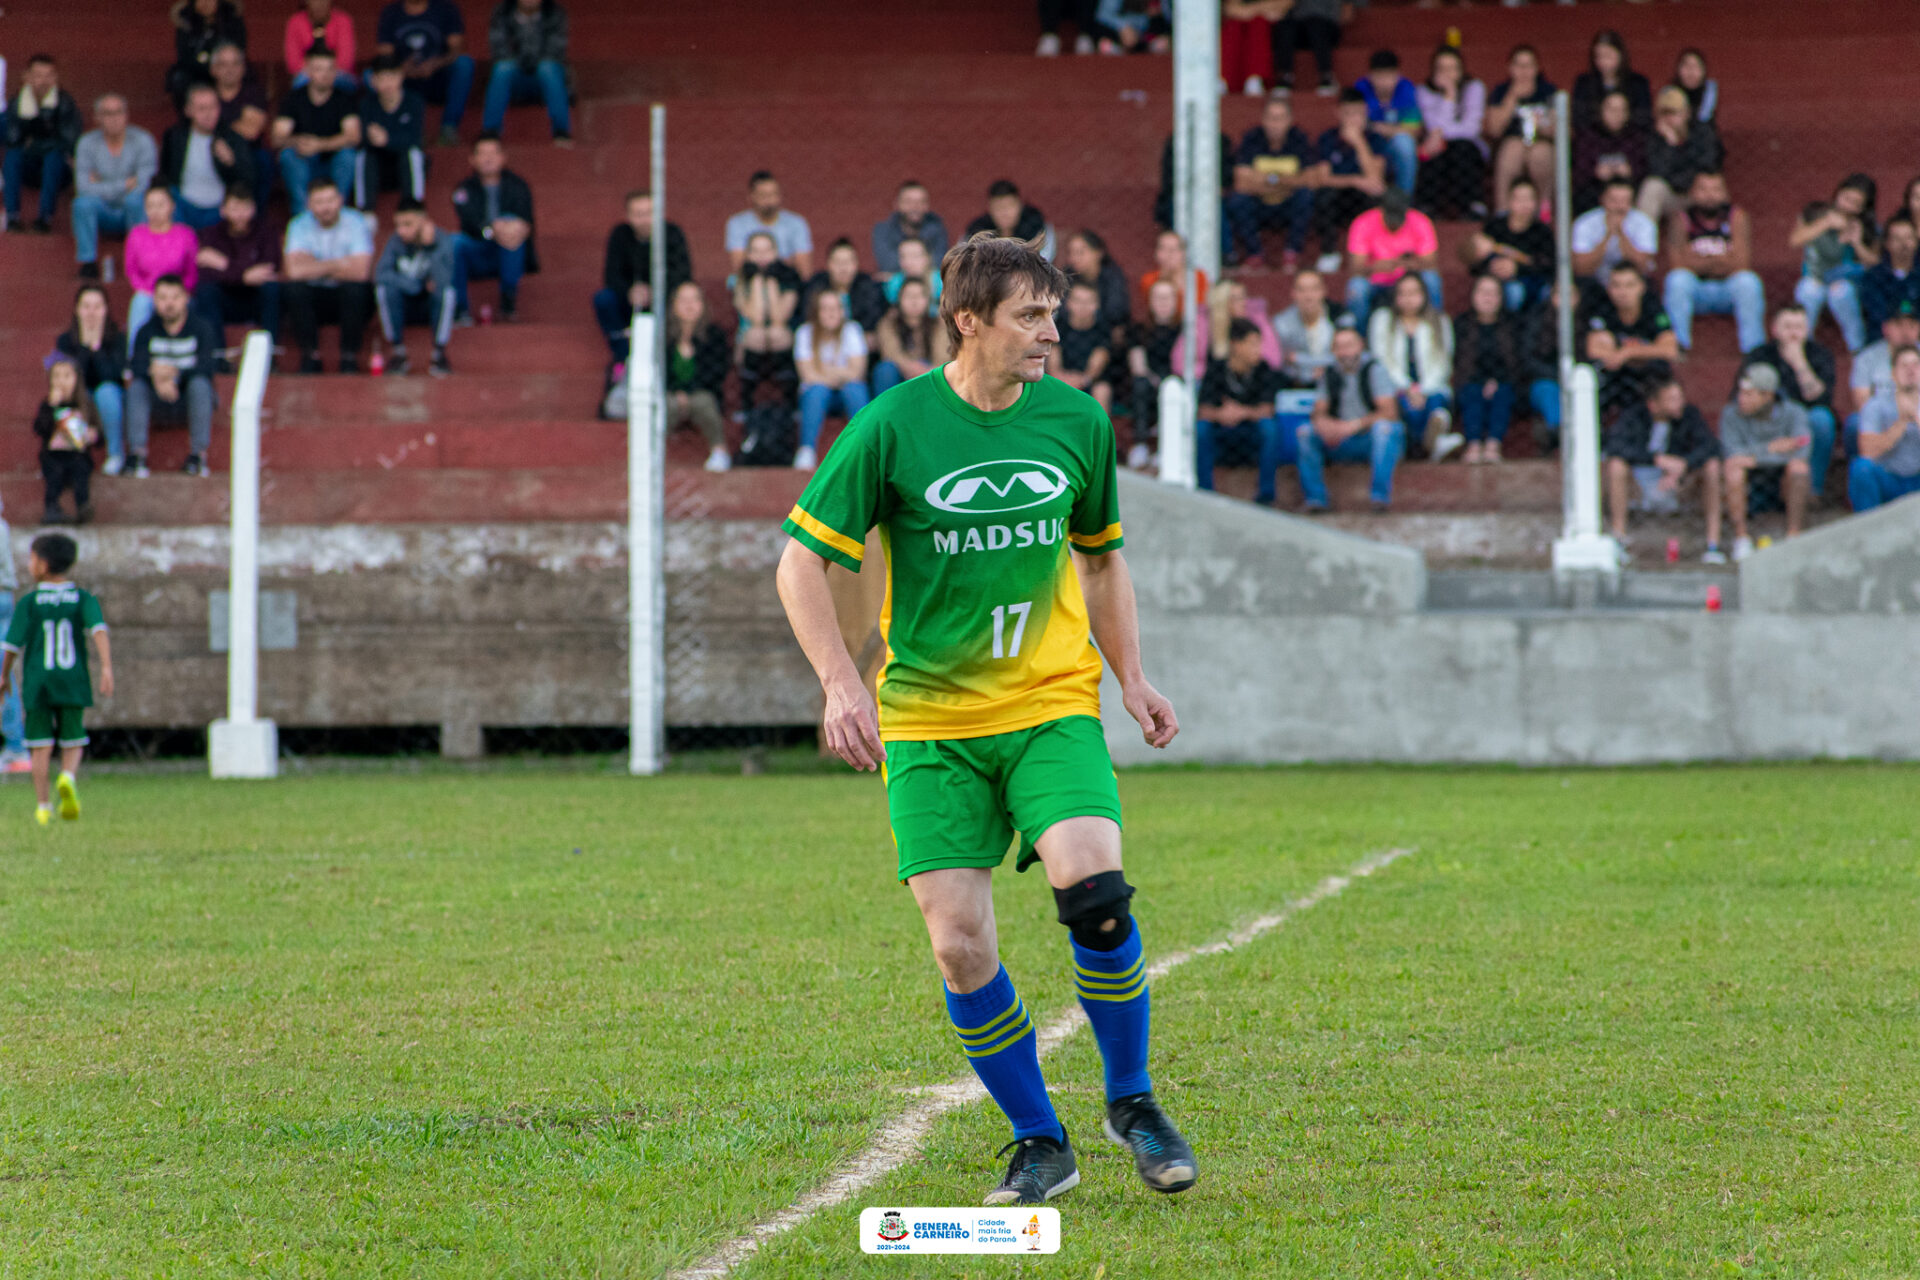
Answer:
0;0;1920;524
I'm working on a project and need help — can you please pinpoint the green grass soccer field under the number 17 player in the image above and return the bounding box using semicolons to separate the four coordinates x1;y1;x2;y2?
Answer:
0;766;1920;1280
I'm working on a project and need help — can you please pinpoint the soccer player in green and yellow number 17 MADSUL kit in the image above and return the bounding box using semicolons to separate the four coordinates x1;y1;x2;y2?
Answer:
780;232;1198;1205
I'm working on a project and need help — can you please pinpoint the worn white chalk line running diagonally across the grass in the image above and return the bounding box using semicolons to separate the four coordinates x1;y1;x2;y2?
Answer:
666;848;1413;1280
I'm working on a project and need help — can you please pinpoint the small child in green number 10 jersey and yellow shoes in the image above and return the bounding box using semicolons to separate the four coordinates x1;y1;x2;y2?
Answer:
0;533;113;827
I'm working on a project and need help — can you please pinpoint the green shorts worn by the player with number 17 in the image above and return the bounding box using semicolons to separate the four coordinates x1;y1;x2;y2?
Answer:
885;716;1119;881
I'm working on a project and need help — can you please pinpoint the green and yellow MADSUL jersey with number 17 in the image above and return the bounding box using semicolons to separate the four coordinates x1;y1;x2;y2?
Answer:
785;367;1121;743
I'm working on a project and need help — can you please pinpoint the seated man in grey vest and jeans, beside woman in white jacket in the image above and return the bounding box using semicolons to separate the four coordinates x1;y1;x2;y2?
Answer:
1296;317;1407;514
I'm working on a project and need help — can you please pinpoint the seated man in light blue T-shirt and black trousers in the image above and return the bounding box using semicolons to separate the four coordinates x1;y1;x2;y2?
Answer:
280;178;372;374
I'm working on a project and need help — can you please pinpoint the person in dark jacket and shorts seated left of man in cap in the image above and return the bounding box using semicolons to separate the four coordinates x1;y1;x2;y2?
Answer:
1601;374;1726;564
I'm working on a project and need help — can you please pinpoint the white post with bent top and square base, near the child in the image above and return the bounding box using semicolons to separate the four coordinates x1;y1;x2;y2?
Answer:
207;330;280;777
